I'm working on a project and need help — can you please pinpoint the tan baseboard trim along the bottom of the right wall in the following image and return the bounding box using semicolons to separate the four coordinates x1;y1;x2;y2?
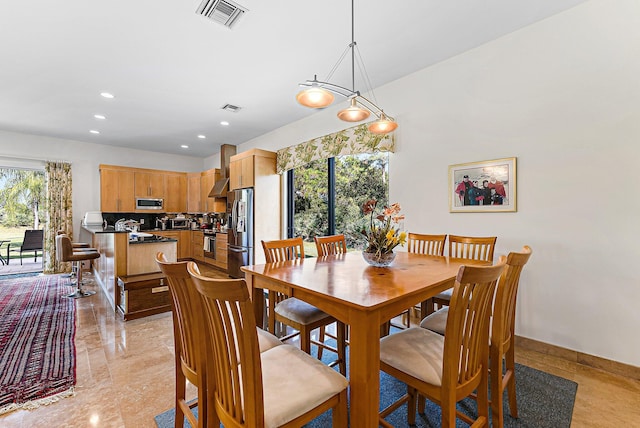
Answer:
515;335;640;380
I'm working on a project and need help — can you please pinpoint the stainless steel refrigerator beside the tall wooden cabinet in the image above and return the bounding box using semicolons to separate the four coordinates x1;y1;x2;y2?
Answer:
227;189;254;278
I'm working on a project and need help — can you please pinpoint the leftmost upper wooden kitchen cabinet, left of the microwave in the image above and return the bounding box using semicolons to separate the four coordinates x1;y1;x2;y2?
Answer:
100;165;136;212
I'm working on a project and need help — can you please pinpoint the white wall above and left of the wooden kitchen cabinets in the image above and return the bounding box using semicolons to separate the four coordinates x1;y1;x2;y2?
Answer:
0;131;204;236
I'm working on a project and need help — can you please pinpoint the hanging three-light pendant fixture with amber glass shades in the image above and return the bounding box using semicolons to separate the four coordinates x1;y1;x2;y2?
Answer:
296;0;398;134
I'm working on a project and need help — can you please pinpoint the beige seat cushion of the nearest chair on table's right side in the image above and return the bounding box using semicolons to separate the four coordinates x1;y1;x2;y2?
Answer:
380;327;444;386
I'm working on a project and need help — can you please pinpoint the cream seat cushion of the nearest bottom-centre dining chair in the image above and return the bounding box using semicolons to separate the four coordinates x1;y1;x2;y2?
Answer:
260;344;350;427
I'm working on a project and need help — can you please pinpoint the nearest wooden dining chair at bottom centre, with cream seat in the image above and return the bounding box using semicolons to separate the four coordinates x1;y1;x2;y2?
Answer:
188;262;348;428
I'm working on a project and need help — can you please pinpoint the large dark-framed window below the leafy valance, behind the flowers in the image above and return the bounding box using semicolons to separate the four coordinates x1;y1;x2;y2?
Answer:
287;152;389;256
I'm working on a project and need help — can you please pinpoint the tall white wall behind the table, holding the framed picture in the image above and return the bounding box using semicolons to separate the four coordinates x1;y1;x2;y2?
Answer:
228;0;640;366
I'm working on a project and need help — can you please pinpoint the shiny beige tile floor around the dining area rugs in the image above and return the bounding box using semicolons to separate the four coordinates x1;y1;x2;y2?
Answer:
0;267;640;428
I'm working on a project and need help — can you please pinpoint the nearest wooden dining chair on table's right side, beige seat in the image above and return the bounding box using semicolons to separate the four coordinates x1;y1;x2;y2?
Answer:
380;262;505;427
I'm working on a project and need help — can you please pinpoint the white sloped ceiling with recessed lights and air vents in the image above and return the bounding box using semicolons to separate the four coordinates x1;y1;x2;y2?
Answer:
0;0;584;157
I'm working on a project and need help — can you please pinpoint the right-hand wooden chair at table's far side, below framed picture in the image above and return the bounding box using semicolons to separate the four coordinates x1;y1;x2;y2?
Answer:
426;235;498;314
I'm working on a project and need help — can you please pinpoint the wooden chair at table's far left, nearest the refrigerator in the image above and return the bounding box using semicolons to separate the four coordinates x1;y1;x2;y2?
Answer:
262;237;347;375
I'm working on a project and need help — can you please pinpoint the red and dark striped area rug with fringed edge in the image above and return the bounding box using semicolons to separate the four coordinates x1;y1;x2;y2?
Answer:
0;275;76;415
